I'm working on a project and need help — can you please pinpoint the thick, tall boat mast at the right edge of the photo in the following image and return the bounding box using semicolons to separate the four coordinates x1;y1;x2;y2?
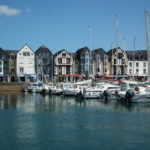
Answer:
145;10;150;81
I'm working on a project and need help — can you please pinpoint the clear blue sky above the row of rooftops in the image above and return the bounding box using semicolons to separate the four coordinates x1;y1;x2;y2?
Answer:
0;0;150;53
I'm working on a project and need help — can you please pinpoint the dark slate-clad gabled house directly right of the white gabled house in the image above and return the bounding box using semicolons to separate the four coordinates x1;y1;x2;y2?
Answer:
35;45;54;82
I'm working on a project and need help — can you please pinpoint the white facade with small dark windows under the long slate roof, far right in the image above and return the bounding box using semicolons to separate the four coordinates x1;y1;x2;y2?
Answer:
128;61;148;76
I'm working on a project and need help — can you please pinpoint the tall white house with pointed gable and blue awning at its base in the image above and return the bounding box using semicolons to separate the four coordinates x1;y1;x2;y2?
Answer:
17;45;36;81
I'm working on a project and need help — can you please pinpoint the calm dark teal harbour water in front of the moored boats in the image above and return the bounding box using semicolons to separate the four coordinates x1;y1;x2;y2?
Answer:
0;93;150;150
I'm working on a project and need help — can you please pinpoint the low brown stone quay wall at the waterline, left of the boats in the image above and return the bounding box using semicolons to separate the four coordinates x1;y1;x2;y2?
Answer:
0;82;26;92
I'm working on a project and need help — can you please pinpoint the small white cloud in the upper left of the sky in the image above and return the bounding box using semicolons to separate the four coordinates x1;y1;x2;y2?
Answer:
0;5;21;16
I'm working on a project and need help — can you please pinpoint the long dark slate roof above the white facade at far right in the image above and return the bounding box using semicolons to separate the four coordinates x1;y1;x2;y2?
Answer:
126;50;148;61
